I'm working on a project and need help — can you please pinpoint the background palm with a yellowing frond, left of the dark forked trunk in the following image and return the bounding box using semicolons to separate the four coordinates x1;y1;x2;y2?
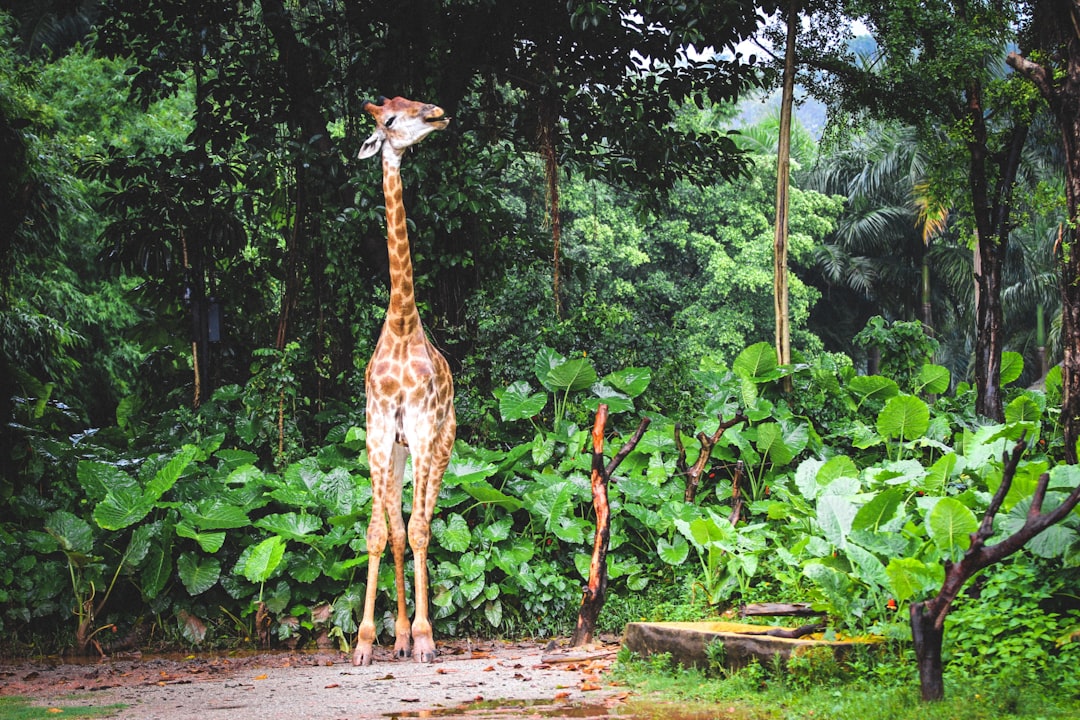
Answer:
805;123;971;371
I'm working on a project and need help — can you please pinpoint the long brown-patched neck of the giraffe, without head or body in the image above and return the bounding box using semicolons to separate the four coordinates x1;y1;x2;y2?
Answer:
382;153;420;336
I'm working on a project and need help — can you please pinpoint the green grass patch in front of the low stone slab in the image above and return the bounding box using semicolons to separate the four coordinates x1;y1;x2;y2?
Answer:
613;651;1080;720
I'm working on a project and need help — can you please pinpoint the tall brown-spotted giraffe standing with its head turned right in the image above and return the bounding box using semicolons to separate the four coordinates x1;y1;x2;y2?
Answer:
352;97;457;665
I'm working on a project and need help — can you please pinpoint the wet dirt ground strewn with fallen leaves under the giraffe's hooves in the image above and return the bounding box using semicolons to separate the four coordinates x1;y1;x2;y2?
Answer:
0;638;629;720
